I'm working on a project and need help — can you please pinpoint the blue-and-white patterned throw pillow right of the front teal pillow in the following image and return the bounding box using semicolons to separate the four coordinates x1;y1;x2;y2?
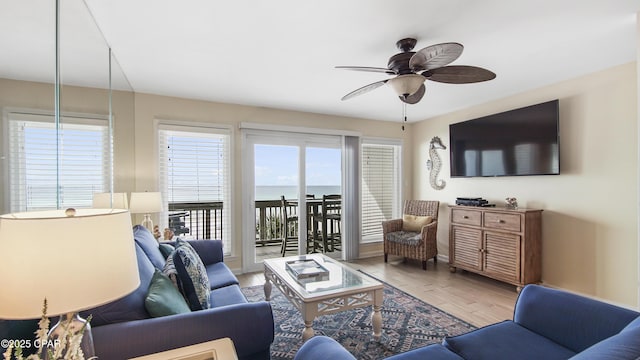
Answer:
167;240;211;311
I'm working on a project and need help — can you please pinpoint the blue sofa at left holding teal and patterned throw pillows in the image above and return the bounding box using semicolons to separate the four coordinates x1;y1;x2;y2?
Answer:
0;225;274;360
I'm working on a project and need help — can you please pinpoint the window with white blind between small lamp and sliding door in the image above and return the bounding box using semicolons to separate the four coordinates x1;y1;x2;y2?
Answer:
158;124;232;254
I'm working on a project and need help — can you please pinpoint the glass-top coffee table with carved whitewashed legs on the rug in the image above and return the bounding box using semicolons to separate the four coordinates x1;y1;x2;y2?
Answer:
264;254;383;341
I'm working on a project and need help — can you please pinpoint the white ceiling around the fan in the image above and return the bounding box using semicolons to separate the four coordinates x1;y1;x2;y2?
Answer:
0;0;640;121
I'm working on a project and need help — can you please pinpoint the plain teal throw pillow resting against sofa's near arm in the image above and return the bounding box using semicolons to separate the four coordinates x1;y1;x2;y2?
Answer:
144;269;191;317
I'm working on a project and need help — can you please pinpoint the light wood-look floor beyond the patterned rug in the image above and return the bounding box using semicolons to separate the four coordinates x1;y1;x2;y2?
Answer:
238;256;518;327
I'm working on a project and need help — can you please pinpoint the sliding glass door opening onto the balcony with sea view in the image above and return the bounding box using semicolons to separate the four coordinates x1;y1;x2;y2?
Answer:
243;131;342;271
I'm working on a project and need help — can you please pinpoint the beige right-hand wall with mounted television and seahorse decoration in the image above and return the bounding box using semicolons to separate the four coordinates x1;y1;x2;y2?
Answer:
412;63;638;306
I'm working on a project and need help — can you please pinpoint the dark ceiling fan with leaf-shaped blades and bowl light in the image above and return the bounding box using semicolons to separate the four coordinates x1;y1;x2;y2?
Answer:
336;38;496;104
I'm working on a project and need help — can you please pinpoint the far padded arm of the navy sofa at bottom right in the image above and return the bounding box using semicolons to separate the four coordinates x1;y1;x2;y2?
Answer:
513;285;639;352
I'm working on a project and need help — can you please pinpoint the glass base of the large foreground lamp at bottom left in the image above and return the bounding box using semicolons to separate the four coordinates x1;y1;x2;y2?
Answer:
43;312;96;359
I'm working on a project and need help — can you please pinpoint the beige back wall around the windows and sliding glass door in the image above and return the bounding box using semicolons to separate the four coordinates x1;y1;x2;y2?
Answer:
131;94;413;271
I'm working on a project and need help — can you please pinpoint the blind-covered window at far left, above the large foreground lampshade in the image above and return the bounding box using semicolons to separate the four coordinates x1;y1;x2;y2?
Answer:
6;112;111;212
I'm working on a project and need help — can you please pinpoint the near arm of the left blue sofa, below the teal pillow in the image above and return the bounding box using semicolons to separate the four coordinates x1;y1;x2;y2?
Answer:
92;301;274;359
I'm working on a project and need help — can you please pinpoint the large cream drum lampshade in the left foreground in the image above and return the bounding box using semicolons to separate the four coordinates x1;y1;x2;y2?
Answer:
0;209;140;319
